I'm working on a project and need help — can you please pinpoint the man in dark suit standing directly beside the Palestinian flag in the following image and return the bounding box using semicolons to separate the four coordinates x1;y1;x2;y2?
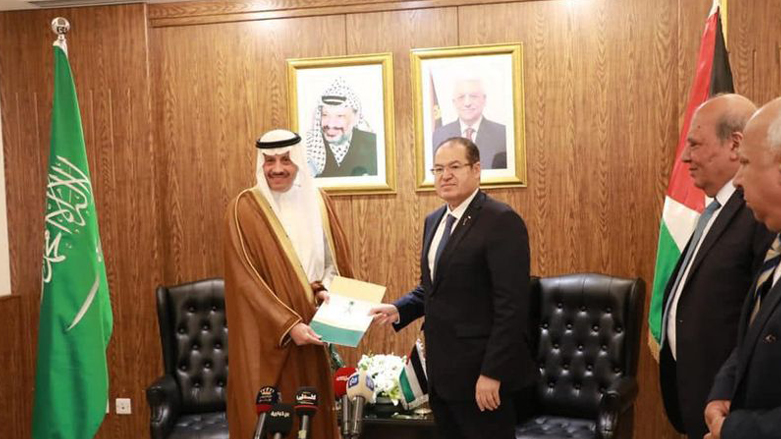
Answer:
659;95;773;439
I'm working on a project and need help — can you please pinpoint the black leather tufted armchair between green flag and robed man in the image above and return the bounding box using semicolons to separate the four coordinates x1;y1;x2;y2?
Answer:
146;279;228;439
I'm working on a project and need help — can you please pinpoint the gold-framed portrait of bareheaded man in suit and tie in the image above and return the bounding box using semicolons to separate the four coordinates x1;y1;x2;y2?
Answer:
411;43;526;190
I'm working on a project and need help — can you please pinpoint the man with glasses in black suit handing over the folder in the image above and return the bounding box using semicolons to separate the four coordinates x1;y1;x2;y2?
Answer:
372;138;537;439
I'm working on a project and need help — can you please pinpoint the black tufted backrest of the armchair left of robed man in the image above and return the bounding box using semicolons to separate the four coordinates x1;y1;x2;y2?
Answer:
157;279;228;413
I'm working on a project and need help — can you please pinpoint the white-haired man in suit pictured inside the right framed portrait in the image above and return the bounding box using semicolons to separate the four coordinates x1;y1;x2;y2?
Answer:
432;78;507;169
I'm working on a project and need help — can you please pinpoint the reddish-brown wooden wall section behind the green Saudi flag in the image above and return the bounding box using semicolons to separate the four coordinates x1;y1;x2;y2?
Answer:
0;5;161;438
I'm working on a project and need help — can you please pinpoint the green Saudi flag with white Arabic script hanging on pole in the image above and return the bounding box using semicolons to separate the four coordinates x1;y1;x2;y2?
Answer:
33;41;113;439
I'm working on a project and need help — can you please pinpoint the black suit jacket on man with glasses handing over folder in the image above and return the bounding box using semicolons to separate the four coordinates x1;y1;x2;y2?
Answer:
394;192;537;400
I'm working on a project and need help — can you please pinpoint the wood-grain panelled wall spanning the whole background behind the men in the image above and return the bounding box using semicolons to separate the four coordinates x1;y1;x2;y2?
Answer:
0;0;781;439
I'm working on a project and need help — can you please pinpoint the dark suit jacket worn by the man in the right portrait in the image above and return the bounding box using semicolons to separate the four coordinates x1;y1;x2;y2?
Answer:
432;117;507;169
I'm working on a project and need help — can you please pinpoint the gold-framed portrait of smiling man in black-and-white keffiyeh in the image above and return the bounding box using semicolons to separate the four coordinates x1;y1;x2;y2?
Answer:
287;53;396;195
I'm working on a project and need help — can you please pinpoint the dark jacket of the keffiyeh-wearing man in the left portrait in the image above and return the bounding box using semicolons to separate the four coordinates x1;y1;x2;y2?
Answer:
318;128;377;177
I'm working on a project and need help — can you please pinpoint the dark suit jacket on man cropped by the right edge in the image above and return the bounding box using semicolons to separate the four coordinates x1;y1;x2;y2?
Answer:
708;248;781;439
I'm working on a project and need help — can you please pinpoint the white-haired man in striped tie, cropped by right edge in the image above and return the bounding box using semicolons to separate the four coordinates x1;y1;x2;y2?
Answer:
705;99;781;439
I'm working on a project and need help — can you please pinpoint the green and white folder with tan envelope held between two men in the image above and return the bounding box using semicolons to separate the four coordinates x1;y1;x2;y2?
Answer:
309;276;385;348
